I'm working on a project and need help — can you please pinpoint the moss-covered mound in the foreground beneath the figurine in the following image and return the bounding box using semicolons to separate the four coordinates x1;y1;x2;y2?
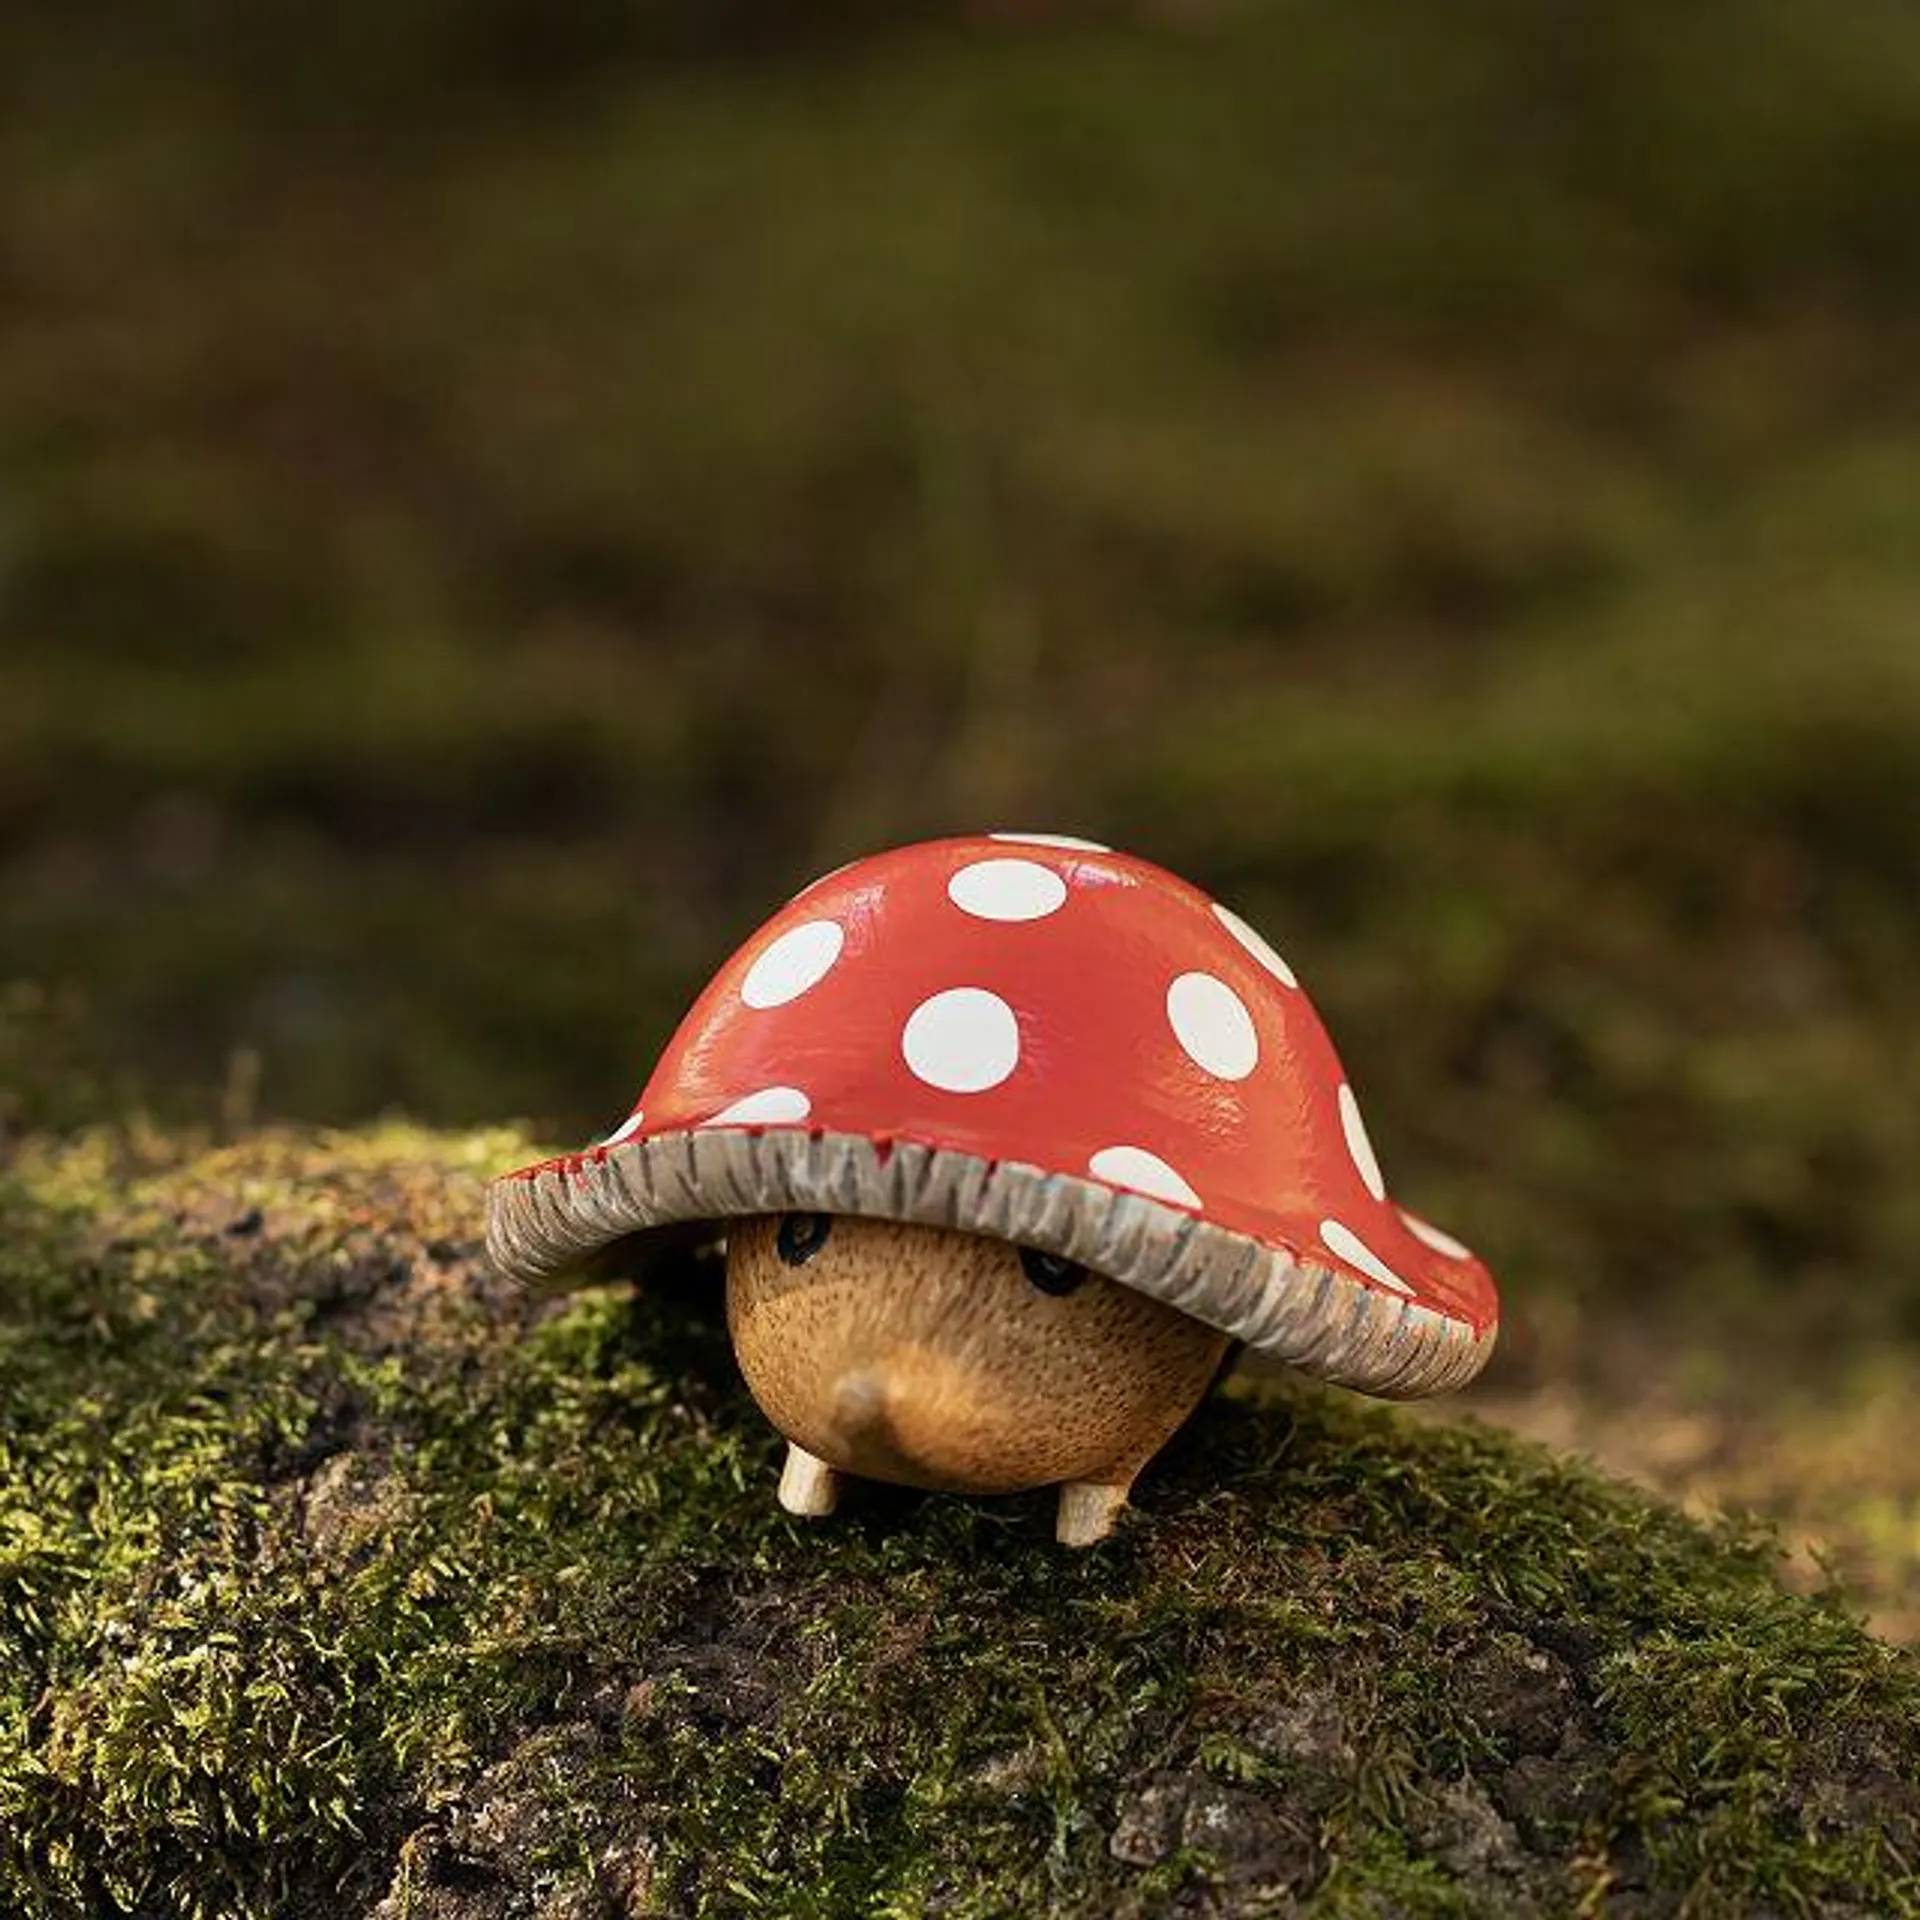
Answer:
0;1127;1920;1920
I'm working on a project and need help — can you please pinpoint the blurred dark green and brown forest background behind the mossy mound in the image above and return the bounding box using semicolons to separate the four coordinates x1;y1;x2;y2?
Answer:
0;0;1920;1619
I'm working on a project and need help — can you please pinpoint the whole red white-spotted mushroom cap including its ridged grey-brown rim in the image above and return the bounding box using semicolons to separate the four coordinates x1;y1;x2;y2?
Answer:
490;833;1498;1394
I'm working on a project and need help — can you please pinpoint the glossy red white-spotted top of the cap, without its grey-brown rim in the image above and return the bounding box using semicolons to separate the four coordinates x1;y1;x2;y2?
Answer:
522;835;1498;1329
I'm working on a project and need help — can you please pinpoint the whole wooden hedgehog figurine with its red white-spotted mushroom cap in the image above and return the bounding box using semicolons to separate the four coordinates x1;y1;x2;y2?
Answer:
488;833;1500;1546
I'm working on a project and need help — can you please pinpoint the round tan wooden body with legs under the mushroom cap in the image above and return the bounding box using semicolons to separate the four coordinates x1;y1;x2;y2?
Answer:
726;1213;1229;1546
